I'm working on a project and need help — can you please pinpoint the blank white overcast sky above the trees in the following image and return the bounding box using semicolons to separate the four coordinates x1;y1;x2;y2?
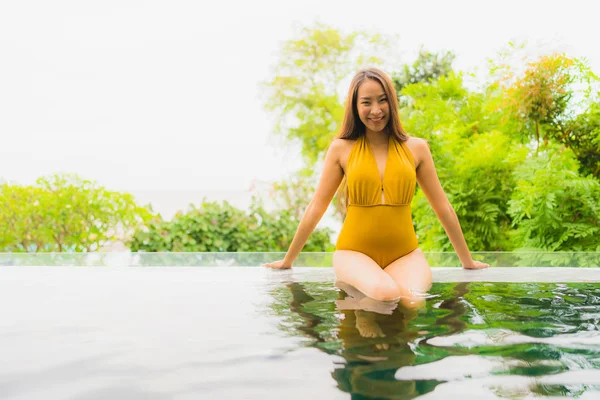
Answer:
0;0;600;218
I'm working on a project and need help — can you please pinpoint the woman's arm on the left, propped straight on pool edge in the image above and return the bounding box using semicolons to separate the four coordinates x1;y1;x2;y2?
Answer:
264;139;344;268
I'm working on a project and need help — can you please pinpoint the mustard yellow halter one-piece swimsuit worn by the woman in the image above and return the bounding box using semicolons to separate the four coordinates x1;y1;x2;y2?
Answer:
335;135;418;268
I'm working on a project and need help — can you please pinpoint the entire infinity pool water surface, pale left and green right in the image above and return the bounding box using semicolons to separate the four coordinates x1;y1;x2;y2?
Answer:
0;255;600;399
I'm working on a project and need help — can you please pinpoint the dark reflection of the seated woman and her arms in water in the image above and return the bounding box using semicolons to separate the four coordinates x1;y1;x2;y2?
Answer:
278;282;466;399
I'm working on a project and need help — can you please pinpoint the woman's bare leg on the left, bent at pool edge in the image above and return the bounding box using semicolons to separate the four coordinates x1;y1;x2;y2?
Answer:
333;250;401;301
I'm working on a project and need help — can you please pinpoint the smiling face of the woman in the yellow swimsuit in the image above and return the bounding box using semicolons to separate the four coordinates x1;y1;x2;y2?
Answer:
356;79;390;132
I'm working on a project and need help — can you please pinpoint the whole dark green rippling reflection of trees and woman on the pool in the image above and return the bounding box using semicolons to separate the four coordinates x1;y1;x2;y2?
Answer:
272;281;600;399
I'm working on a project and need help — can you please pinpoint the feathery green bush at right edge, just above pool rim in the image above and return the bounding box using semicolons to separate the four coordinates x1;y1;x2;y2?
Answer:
508;145;600;251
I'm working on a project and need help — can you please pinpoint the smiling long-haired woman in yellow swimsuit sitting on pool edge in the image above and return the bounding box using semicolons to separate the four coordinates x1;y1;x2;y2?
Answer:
265;68;489;301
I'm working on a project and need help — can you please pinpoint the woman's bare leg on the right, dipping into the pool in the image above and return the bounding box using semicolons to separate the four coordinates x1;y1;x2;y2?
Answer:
384;249;431;308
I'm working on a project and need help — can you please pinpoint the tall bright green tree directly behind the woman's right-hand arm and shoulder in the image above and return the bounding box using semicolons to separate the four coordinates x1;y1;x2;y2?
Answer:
402;73;527;251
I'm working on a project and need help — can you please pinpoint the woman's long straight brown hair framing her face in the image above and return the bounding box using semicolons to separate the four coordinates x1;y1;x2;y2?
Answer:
336;68;408;214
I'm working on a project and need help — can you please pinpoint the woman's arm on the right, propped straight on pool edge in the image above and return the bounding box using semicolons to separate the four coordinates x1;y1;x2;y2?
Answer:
414;138;489;269
